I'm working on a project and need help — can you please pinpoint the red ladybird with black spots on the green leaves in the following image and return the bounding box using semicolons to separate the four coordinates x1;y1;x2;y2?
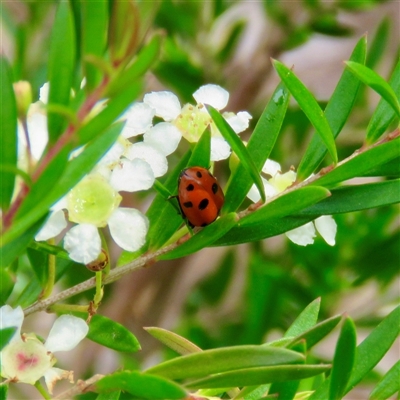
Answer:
178;167;224;226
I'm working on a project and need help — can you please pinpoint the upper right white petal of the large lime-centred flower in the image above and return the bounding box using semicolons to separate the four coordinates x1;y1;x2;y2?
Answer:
110;158;154;192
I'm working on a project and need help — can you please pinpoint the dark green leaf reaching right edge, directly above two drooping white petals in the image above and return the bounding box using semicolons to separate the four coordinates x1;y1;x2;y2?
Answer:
301;179;400;217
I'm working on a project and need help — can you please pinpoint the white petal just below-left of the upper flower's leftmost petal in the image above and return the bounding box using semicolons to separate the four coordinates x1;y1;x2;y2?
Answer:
121;102;155;138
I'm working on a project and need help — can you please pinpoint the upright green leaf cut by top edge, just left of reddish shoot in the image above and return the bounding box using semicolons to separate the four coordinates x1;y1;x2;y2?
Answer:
81;0;108;92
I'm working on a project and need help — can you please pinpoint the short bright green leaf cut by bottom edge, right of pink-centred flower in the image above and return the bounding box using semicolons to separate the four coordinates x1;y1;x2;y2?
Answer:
95;371;187;400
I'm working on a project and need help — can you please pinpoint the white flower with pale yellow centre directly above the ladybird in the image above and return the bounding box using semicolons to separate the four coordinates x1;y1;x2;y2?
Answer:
143;84;251;161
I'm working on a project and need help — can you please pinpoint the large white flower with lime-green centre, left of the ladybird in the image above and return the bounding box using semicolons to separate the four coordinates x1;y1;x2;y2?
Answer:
35;175;149;264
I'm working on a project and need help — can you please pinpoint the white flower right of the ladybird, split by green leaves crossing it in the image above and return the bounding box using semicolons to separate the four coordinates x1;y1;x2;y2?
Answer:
247;160;337;246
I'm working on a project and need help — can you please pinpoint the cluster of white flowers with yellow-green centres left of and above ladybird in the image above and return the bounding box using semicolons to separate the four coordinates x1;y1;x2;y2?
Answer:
35;85;251;264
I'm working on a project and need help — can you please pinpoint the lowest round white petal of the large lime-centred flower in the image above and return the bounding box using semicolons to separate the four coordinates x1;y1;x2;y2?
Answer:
64;224;101;264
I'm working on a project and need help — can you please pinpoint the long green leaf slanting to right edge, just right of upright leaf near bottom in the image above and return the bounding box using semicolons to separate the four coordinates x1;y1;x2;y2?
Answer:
346;306;400;393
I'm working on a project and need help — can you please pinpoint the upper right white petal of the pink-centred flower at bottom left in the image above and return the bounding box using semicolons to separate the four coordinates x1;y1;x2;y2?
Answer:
44;314;89;353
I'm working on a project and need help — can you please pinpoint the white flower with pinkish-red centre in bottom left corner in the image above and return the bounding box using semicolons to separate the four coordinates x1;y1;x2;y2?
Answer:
0;305;89;393
